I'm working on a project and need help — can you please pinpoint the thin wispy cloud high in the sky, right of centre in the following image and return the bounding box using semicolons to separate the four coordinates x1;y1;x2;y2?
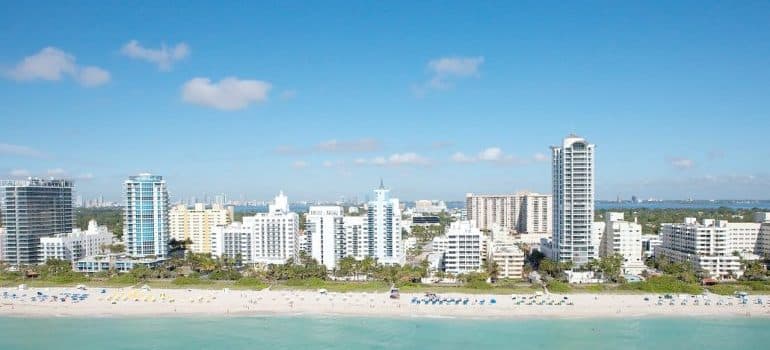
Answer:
414;56;484;96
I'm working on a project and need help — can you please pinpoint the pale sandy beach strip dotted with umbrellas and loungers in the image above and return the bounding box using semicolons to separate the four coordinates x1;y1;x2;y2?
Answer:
0;288;770;318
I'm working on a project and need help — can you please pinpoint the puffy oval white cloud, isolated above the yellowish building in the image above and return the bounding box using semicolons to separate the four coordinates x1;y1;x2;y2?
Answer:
182;77;271;111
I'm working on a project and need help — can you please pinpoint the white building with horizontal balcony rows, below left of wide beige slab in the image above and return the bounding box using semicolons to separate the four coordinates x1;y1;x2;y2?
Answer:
444;221;484;275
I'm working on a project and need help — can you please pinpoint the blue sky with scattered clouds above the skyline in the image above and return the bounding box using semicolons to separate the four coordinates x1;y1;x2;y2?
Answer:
0;1;770;201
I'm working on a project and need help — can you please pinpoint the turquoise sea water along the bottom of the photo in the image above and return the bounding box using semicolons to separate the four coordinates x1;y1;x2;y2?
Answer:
0;317;770;350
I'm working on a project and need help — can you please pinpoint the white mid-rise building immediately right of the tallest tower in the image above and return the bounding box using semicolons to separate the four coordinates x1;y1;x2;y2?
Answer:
599;212;646;275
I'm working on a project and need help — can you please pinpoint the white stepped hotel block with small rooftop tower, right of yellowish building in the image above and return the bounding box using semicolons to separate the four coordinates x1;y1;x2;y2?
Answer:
211;192;299;264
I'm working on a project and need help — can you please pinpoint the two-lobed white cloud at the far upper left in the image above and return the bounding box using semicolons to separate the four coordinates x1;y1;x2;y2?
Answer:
6;47;110;87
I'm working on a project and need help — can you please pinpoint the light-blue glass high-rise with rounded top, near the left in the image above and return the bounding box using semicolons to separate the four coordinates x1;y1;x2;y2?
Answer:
123;174;170;258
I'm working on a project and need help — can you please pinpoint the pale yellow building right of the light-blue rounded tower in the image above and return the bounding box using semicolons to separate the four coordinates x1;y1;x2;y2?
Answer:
169;203;232;254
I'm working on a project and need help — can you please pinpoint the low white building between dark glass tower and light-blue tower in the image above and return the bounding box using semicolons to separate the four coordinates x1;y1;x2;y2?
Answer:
40;220;112;262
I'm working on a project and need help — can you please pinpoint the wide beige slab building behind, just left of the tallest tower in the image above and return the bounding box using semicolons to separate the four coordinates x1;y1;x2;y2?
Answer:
465;192;552;234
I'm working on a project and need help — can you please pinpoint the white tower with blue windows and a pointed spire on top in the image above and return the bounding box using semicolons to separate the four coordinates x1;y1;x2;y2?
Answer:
364;181;405;265
